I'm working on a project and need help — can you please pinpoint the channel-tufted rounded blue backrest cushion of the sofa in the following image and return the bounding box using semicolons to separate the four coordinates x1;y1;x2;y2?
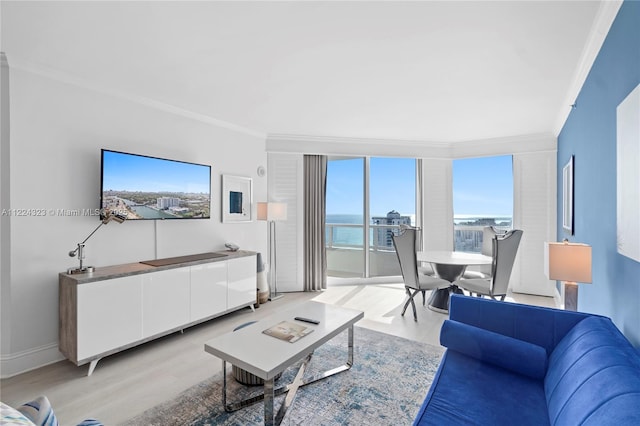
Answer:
544;317;640;425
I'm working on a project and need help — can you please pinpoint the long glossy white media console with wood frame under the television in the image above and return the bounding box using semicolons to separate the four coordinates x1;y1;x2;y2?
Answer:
59;250;257;375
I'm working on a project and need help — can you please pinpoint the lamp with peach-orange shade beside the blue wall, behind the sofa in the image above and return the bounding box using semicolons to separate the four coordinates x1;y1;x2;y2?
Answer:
544;240;591;311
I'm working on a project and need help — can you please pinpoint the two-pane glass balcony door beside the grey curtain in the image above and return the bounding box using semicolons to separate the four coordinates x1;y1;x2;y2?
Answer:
326;157;416;278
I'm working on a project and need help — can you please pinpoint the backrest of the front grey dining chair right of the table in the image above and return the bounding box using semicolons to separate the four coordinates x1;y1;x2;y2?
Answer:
491;229;522;295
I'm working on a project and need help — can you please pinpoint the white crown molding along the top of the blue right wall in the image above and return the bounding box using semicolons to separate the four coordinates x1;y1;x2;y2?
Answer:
553;0;623;136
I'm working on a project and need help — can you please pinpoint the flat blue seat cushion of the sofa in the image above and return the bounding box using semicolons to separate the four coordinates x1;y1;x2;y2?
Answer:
414;349;549;426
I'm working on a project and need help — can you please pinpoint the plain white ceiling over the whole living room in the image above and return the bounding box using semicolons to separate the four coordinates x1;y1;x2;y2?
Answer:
1;1;619;142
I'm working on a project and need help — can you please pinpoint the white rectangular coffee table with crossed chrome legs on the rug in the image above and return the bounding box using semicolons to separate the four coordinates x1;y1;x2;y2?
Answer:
204;302;364;425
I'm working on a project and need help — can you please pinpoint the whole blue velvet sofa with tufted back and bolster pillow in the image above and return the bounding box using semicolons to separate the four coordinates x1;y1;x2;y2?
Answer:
414;295;640;426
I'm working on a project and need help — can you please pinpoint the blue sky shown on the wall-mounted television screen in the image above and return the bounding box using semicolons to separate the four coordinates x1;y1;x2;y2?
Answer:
102;151;211;194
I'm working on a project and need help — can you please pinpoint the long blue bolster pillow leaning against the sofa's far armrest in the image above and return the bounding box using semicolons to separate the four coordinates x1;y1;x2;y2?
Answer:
440;320;547;379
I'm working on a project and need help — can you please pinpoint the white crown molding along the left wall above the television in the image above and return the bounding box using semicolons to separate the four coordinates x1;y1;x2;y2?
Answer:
4;55;267;139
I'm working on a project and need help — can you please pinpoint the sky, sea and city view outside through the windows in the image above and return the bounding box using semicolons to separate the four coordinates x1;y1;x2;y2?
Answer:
326;156;513;252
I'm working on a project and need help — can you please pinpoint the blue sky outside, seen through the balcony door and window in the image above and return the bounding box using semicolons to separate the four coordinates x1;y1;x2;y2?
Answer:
327;156;513;217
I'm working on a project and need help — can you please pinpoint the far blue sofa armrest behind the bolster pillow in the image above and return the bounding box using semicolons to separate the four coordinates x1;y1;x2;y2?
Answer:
449;294;593;354
